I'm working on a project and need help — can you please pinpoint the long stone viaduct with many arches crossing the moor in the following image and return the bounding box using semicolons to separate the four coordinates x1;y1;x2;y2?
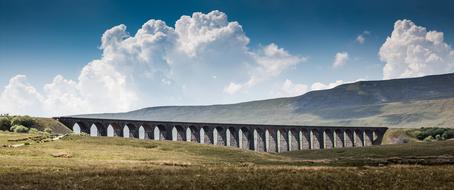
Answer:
54;117;387;152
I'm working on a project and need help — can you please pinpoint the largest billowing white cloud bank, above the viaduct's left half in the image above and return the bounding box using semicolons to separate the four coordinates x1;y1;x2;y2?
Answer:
0;11;305;116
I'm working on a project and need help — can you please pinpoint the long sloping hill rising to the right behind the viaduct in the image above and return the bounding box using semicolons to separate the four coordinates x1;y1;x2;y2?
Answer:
75;74;454;127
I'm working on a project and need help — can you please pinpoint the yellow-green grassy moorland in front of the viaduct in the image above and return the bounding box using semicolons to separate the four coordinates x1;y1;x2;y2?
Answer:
0;133;454;189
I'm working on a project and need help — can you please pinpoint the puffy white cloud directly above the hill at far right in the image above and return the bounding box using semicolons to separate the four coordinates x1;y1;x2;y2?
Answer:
379;20;454;79
